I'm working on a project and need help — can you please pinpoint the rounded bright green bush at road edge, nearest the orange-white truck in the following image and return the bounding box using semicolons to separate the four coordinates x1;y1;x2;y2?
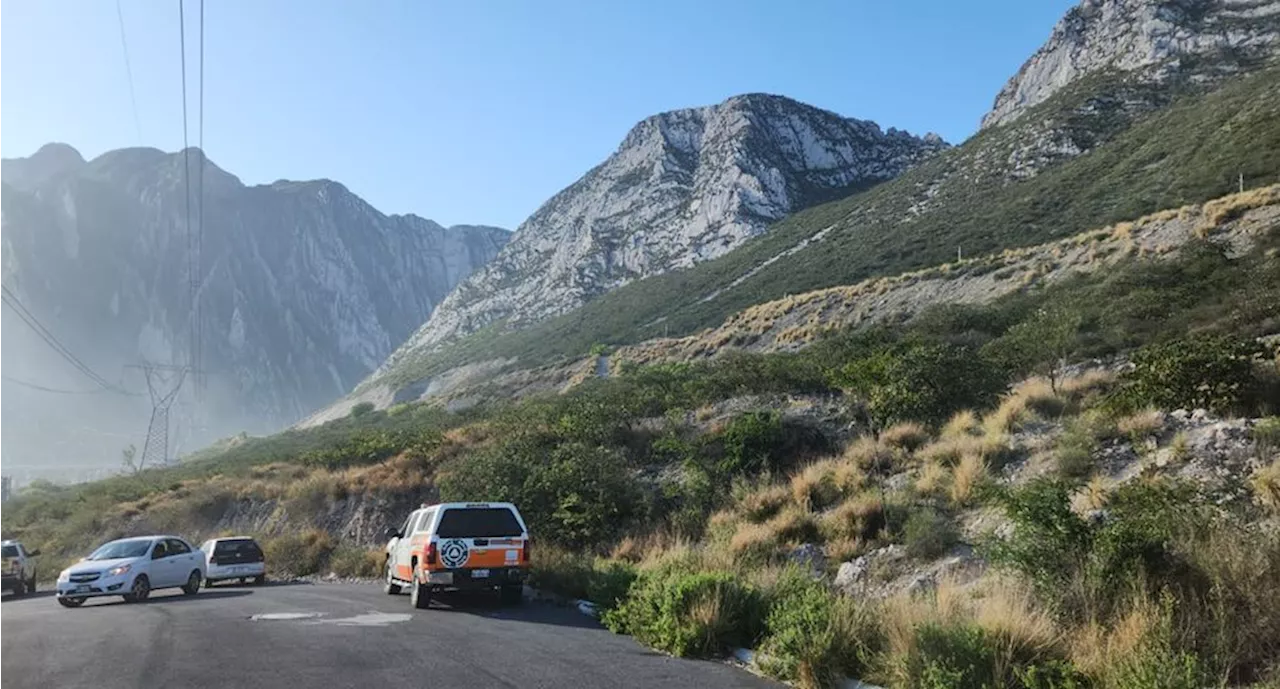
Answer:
603;565;760;657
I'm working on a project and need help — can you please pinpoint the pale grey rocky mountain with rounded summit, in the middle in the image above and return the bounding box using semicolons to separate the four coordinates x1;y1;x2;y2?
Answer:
373;93;947;368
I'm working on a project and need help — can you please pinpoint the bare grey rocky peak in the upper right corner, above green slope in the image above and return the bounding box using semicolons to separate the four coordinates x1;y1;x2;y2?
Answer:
982;0;1280;128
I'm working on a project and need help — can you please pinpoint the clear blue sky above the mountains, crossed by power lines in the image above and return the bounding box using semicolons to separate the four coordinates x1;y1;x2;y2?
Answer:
0;0;1075;228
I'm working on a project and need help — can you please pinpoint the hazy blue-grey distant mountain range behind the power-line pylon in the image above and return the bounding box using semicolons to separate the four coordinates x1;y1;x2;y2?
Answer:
0;145;509;468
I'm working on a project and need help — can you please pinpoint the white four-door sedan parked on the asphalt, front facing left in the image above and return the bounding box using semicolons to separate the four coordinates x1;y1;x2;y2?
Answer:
58;535;205;607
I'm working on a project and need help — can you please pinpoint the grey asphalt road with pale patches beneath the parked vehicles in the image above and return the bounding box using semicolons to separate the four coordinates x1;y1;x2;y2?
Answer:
0;584;780;689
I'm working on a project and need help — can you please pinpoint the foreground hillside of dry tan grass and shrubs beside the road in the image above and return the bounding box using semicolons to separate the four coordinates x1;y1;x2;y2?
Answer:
0;197;1280;689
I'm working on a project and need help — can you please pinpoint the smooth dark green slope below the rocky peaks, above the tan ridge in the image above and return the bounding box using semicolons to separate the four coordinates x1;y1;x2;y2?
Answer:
378;64;1280;384
